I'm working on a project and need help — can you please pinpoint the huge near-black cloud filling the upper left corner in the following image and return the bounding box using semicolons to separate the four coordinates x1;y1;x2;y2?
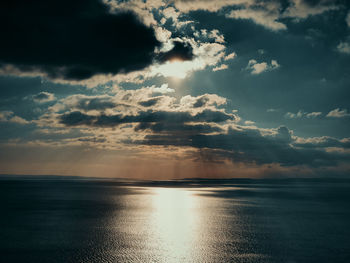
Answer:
0;0;160;80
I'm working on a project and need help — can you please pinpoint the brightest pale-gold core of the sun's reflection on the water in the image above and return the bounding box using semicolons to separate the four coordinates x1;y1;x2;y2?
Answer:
152;188;198;262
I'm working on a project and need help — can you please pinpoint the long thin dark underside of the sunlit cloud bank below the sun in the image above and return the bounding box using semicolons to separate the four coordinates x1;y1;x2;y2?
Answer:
60;110;235;127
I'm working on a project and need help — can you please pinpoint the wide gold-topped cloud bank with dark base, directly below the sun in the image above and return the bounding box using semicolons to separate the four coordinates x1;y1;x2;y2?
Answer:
55;91;238;127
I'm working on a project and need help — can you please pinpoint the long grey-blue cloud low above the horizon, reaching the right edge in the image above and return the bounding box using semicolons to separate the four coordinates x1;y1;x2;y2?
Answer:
132;127;350;167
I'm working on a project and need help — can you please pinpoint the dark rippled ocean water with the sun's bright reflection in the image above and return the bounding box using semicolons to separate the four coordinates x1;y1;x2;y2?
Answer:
0;178;350;263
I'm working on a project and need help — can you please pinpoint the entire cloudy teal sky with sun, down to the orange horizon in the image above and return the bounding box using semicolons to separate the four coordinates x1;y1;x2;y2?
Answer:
0;0;350;179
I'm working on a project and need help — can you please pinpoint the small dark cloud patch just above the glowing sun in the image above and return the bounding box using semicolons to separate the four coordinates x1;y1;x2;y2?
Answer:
157;41;194;63
